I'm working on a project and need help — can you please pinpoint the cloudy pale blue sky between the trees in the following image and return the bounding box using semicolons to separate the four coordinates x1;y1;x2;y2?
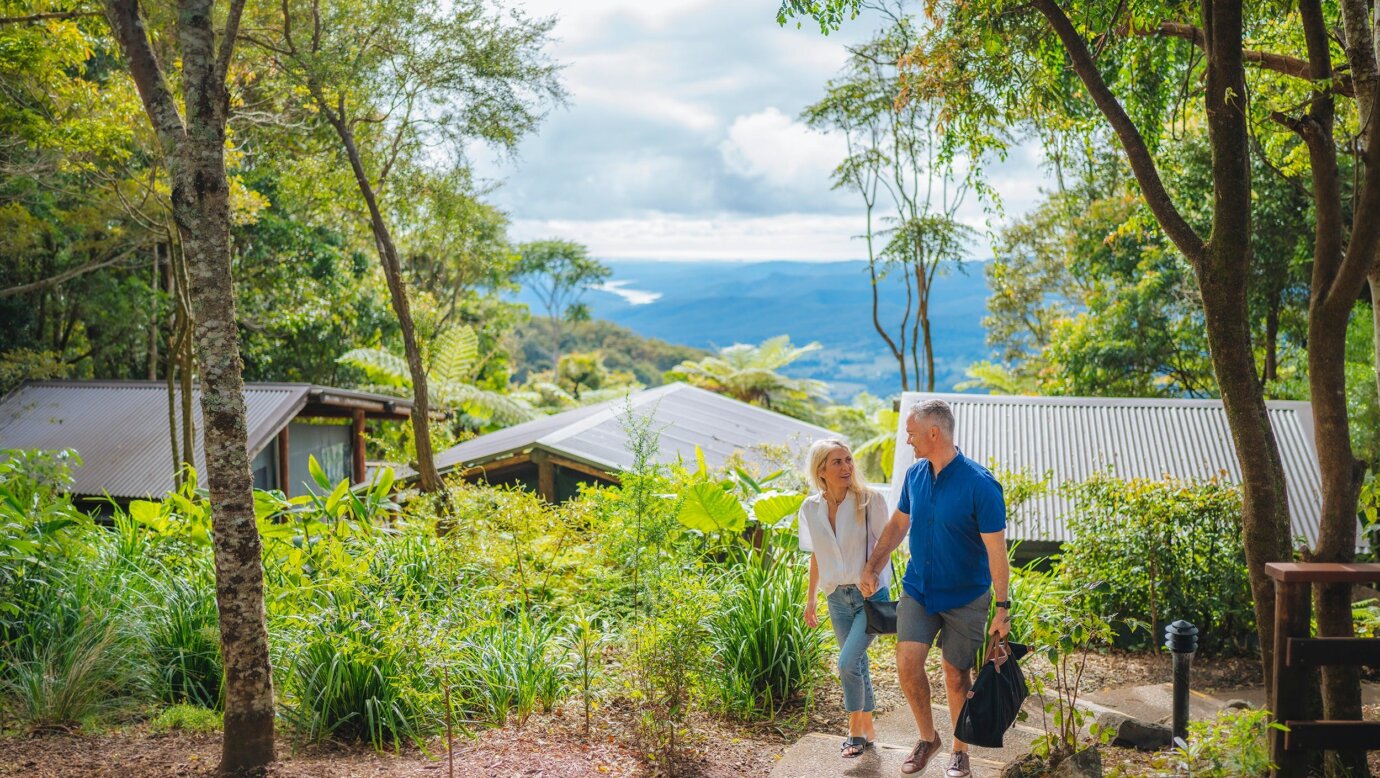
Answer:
475;0;1042;259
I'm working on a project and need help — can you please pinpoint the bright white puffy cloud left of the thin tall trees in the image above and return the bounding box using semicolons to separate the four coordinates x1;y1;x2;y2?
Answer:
719;106;847;189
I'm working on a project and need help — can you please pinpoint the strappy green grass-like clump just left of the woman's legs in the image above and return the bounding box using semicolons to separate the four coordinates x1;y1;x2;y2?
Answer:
709;557;825;717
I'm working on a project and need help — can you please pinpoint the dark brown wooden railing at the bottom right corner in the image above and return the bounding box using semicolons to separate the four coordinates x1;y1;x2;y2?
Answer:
1265;561;1380;778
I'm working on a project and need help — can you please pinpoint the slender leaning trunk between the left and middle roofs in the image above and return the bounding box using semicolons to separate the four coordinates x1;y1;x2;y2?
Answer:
312;102;440;491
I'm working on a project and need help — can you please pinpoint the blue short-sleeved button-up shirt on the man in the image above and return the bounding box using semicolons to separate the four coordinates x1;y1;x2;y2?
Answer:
896;451;1006;612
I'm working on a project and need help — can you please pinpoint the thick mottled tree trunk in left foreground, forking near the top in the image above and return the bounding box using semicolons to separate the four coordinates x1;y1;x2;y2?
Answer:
106;0;275;775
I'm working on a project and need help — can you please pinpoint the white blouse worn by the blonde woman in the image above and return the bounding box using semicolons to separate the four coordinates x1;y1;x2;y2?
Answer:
798;491;891;596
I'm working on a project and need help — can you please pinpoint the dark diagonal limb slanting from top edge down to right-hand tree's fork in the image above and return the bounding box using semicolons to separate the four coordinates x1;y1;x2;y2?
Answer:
1032;0;1203;265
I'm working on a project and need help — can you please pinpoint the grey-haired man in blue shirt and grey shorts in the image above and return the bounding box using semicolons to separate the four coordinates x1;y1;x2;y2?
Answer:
858;400;1012;778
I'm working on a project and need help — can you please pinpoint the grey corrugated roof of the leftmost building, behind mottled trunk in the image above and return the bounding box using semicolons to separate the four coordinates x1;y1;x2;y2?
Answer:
0;381;410;498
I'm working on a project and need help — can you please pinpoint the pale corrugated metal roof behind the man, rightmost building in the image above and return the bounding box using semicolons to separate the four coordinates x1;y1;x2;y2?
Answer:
890;392;1322;545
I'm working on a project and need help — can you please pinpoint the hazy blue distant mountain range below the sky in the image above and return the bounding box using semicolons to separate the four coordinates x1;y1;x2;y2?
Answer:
518;259;989;400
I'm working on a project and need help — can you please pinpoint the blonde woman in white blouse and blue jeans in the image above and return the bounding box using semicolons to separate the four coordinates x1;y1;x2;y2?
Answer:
799;440;891;759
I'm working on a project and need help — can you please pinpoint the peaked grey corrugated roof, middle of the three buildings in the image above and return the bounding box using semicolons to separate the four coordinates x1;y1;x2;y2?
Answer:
436;383;838;472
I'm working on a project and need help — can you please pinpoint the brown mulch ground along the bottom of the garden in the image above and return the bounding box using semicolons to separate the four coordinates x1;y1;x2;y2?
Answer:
0;651;1302;778
